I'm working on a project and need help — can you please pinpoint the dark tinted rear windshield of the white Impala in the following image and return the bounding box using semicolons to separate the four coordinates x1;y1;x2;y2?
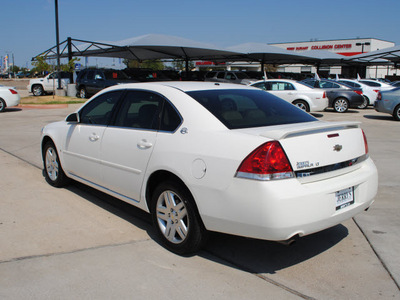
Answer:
186;89;317;129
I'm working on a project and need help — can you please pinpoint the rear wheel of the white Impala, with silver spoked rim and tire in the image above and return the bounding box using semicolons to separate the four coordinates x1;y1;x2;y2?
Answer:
151;181;207;255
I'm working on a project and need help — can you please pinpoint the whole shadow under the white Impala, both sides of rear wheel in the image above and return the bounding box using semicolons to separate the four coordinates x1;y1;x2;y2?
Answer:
60;181;348;274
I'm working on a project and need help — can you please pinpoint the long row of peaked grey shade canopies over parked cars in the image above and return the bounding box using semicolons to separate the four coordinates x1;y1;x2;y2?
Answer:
39;34;390;66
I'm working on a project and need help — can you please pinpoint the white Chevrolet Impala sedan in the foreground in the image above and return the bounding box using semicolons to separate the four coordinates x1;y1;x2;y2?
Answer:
41;82;378;254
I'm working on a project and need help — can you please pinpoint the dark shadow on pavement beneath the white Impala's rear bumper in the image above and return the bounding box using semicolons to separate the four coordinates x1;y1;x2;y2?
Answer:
202;224;349;274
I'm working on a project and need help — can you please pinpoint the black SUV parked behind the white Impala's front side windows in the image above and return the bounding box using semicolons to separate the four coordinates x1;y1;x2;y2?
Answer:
76;69;137;98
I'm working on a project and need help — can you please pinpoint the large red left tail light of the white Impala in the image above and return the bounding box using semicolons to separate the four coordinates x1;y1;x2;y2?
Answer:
236;141;294;180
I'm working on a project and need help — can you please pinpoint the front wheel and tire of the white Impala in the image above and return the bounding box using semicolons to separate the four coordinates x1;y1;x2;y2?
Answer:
43;141;69;187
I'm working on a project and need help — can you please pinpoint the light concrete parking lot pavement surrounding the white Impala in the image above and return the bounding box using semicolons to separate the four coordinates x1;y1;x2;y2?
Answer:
0;91;400;299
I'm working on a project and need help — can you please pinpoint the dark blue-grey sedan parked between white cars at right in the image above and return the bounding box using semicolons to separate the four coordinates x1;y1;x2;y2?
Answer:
301;78;367;113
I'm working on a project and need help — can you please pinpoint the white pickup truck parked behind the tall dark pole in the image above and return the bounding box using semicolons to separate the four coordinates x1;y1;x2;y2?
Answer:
26;72;70;96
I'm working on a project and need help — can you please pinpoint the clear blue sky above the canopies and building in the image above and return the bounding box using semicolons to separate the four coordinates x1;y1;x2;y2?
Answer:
0;0;400;68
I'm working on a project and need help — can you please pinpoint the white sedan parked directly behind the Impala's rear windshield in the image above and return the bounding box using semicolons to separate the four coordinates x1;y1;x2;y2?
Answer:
251;79;329;112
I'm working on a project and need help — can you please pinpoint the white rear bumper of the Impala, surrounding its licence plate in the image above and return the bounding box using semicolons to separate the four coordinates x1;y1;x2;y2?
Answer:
197;159;378;240
